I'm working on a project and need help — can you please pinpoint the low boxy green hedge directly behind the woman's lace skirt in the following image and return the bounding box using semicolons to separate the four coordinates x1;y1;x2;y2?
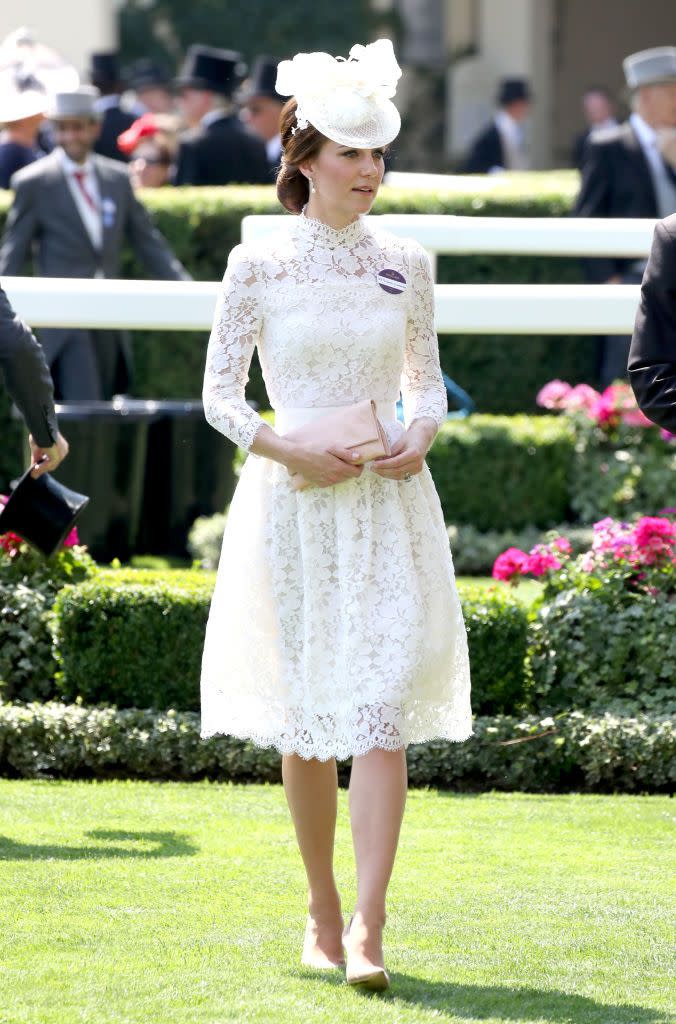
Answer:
53;570;527;714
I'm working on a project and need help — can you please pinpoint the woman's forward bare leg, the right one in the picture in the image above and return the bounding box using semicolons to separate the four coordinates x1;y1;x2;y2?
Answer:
349;750;408;973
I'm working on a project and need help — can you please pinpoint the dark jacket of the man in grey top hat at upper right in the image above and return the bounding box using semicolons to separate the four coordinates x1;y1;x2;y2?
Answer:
574;121;659;284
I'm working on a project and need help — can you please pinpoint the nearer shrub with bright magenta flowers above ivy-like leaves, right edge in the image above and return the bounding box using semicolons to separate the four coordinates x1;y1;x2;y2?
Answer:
493;509;676;714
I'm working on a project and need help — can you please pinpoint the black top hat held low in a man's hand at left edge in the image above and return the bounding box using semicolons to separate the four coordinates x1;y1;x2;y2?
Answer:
0;469;89;558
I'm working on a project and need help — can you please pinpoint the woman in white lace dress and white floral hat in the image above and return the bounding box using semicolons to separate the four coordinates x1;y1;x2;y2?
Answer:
202;40;471;988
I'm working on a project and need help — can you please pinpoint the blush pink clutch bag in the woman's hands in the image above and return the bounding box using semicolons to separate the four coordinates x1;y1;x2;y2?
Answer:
284;398;390;490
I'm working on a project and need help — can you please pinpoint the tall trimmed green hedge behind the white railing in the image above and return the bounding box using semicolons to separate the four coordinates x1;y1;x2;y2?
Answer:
0;171;594;483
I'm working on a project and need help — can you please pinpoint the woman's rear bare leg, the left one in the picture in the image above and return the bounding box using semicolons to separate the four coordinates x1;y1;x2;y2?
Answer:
282;754;343;967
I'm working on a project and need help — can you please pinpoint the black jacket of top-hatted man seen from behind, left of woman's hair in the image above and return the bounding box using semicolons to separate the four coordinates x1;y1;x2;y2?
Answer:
174;114;270;185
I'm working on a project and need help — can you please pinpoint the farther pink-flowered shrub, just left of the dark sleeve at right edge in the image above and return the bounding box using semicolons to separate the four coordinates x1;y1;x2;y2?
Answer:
537;380;676;522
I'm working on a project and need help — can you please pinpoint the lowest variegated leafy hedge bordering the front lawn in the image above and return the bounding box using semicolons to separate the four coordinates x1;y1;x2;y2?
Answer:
0;702;676;793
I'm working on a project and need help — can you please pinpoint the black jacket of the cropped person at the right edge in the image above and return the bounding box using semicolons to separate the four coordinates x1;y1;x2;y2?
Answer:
629;214;676;433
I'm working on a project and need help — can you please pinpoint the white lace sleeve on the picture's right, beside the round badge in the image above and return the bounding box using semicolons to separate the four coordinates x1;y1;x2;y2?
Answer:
402;243;449;427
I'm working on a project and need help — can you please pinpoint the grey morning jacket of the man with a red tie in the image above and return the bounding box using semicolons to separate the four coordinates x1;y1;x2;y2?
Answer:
0;152;189;391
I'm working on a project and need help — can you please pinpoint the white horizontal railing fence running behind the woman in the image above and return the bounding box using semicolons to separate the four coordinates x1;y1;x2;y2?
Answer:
2;214;654;335
